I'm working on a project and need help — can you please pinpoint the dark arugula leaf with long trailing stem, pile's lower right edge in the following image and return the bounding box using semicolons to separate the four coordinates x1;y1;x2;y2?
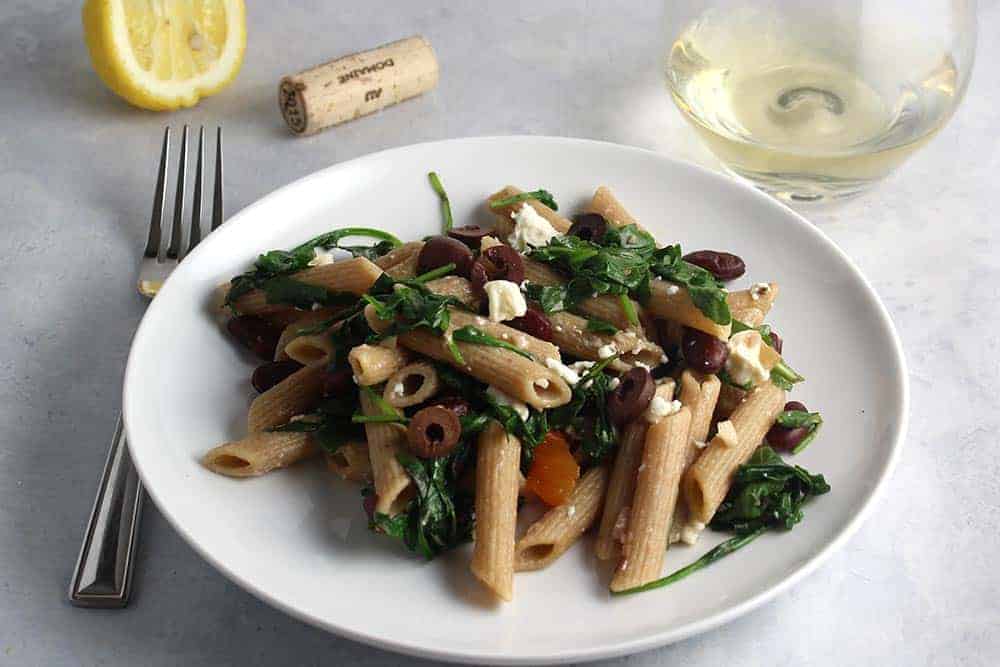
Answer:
612;446;830;595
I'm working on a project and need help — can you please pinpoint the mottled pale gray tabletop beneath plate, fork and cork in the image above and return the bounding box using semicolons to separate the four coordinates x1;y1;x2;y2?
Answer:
0;0;1000;667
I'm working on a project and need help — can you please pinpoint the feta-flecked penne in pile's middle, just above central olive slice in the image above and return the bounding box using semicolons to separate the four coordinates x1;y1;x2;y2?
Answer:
548;311;663;372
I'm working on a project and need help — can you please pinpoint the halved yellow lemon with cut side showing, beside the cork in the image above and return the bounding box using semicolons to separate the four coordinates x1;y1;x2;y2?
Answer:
83;0;246;111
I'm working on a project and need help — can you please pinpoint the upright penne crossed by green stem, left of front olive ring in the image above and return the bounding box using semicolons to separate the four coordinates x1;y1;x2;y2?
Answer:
360;391;413;516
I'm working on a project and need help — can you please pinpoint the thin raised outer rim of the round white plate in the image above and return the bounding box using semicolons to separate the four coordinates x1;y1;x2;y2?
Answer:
122;135;910;665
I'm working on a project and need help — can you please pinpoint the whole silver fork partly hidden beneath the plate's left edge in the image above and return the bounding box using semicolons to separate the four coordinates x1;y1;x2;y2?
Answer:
69;125;223;609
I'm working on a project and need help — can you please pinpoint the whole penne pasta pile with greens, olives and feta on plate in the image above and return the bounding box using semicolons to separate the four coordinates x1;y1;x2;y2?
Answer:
203;173;830;600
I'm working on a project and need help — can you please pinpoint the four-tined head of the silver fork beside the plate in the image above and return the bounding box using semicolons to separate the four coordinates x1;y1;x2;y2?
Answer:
143;125;223;263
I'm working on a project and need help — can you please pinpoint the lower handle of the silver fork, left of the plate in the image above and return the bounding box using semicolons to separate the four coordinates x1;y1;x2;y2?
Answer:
69;415;143;609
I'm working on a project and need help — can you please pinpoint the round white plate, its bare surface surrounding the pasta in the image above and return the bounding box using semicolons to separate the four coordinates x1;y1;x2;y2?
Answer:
124;137;907;664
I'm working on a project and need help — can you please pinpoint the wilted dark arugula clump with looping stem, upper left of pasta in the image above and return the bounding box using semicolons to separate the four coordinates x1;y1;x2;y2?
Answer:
226;227;403;308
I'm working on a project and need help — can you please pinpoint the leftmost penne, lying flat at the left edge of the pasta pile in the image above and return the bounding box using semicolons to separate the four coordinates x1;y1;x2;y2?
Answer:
201;431;319;477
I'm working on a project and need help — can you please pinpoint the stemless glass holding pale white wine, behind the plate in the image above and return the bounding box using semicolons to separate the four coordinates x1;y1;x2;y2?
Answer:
666;0;976;202
